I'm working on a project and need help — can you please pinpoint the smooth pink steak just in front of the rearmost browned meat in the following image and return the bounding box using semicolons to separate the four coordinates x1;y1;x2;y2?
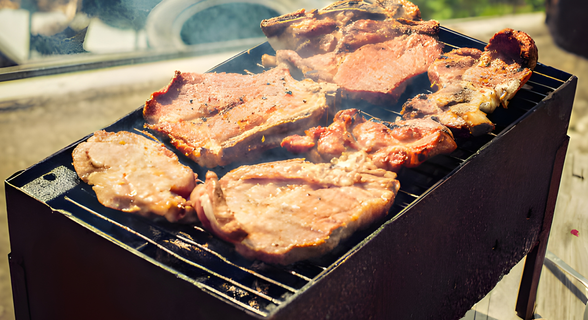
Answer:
276;33;443;104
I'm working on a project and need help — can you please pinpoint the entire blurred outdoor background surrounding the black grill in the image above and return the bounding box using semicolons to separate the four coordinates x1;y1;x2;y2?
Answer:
0;0;588;320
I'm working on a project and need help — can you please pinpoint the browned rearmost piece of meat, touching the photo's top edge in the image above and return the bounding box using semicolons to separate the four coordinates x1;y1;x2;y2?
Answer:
261;0;421;58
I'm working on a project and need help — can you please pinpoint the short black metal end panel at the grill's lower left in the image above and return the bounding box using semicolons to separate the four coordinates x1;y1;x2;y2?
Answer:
6;184;256;320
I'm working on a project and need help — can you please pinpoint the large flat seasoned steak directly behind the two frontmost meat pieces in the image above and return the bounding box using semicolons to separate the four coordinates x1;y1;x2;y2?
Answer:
143;67;338;167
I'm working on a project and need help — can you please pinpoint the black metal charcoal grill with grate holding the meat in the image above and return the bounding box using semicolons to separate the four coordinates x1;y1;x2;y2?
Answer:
5;28;577;320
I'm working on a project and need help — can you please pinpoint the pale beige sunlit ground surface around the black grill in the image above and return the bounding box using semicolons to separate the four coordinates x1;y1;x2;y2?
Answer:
0;13;588;320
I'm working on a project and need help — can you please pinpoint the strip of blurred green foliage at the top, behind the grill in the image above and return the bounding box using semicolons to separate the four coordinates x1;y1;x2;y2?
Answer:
411;0;545;20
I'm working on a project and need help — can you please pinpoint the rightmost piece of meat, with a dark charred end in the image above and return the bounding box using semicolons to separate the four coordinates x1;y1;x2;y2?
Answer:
402;29;537;135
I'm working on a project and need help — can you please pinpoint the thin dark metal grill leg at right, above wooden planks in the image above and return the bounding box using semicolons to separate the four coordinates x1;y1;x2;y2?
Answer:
516;136;570;320
